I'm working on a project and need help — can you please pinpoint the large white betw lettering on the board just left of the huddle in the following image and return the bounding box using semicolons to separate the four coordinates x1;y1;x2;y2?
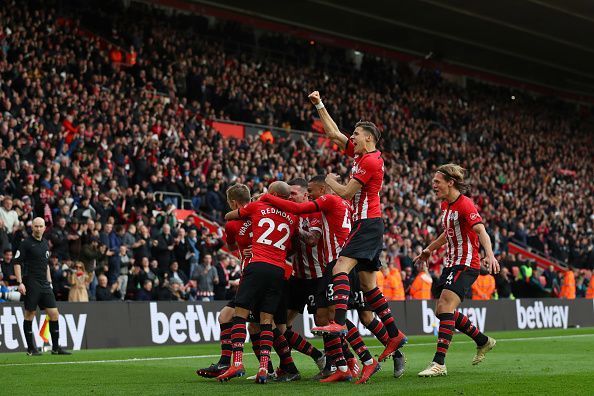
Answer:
150;302;221;344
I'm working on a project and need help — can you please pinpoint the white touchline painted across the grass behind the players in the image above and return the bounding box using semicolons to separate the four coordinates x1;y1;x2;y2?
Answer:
0;334;594;367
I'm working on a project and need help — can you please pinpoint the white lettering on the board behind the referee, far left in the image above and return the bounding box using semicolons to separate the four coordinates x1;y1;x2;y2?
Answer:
0;307;87;350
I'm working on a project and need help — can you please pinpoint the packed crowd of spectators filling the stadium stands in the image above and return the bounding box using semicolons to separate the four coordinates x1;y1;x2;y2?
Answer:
0;1;594;301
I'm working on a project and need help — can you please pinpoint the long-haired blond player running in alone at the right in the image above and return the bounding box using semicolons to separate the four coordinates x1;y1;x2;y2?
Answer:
414;164;499;377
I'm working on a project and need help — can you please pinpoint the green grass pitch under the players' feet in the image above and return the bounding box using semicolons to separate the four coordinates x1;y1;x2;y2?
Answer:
0;328;594;396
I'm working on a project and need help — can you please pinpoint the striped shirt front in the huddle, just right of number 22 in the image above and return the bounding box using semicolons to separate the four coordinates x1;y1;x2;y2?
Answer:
293;212;326;279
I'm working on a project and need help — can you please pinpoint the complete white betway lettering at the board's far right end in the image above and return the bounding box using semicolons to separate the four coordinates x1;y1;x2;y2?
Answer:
516;300;569;329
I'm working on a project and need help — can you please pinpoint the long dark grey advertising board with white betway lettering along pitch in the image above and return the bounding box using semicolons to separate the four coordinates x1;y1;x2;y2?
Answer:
0;299;594;352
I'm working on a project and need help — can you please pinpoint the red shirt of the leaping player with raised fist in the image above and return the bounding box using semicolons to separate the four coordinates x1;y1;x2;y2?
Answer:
345;139;384;222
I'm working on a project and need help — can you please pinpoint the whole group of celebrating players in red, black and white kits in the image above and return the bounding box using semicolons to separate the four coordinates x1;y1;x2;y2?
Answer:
197;91;499;384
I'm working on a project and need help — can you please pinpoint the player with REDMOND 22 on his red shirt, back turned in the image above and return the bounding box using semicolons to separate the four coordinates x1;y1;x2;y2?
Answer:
217;181;298;384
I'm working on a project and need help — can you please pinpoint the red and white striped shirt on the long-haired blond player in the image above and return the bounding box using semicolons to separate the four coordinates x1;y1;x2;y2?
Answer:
441;194;483;269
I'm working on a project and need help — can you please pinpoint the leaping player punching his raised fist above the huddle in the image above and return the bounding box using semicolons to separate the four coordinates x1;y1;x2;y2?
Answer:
302;91;407;361
